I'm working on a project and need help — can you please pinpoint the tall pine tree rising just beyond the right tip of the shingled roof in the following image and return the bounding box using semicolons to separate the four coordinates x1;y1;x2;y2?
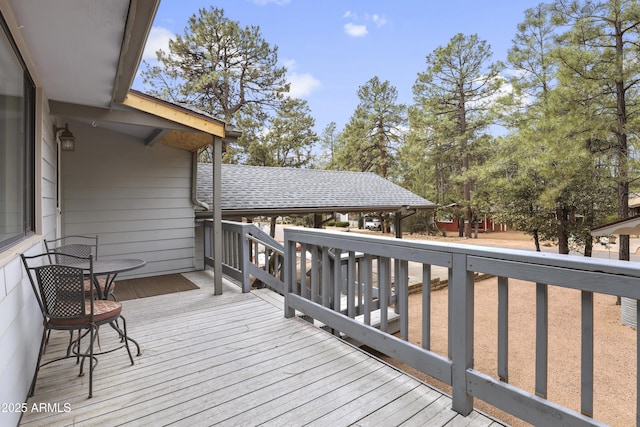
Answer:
411;34;503;241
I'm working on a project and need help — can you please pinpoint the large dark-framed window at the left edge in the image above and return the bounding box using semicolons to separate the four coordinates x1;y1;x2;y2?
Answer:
0;16;35;250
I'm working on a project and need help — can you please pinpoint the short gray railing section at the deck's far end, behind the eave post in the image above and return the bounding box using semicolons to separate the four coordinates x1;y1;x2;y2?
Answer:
204;221;284;293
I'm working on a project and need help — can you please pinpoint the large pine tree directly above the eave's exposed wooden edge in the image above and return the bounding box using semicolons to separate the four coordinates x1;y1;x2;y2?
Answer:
141;7;289;157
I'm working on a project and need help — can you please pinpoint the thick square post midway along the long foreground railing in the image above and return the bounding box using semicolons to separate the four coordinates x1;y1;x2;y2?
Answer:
449;254;474;416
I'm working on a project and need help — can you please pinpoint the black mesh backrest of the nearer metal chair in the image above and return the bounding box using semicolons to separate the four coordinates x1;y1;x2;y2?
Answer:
21;253;94;320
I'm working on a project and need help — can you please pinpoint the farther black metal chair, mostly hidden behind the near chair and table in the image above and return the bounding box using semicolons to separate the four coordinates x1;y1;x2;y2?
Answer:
44;235;117;301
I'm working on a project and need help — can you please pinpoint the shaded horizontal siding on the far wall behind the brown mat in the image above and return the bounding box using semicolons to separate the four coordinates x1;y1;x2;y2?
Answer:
62;123;195;277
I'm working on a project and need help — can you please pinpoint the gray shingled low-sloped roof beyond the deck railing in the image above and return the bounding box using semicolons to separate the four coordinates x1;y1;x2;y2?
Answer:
197;163;436;217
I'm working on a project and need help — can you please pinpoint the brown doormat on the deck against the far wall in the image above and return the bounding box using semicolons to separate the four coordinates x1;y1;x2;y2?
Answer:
114;274;199;301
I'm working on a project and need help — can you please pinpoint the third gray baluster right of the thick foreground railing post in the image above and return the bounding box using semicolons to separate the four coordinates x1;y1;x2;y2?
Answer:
580;291;593;417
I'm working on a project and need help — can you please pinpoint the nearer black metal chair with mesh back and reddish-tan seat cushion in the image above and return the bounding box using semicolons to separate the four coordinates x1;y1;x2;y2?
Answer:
21;252;134;397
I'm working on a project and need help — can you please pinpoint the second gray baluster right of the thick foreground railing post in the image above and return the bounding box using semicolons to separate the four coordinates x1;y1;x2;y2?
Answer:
535;283;549;399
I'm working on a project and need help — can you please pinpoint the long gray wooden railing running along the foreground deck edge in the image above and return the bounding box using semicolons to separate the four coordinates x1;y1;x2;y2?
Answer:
285;228;640;425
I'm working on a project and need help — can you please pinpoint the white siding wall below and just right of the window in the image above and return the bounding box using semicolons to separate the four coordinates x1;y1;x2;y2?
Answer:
0;97;56;426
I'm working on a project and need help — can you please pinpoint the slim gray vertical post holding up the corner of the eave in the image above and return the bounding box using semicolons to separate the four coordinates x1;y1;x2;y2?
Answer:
212;136;222;295
